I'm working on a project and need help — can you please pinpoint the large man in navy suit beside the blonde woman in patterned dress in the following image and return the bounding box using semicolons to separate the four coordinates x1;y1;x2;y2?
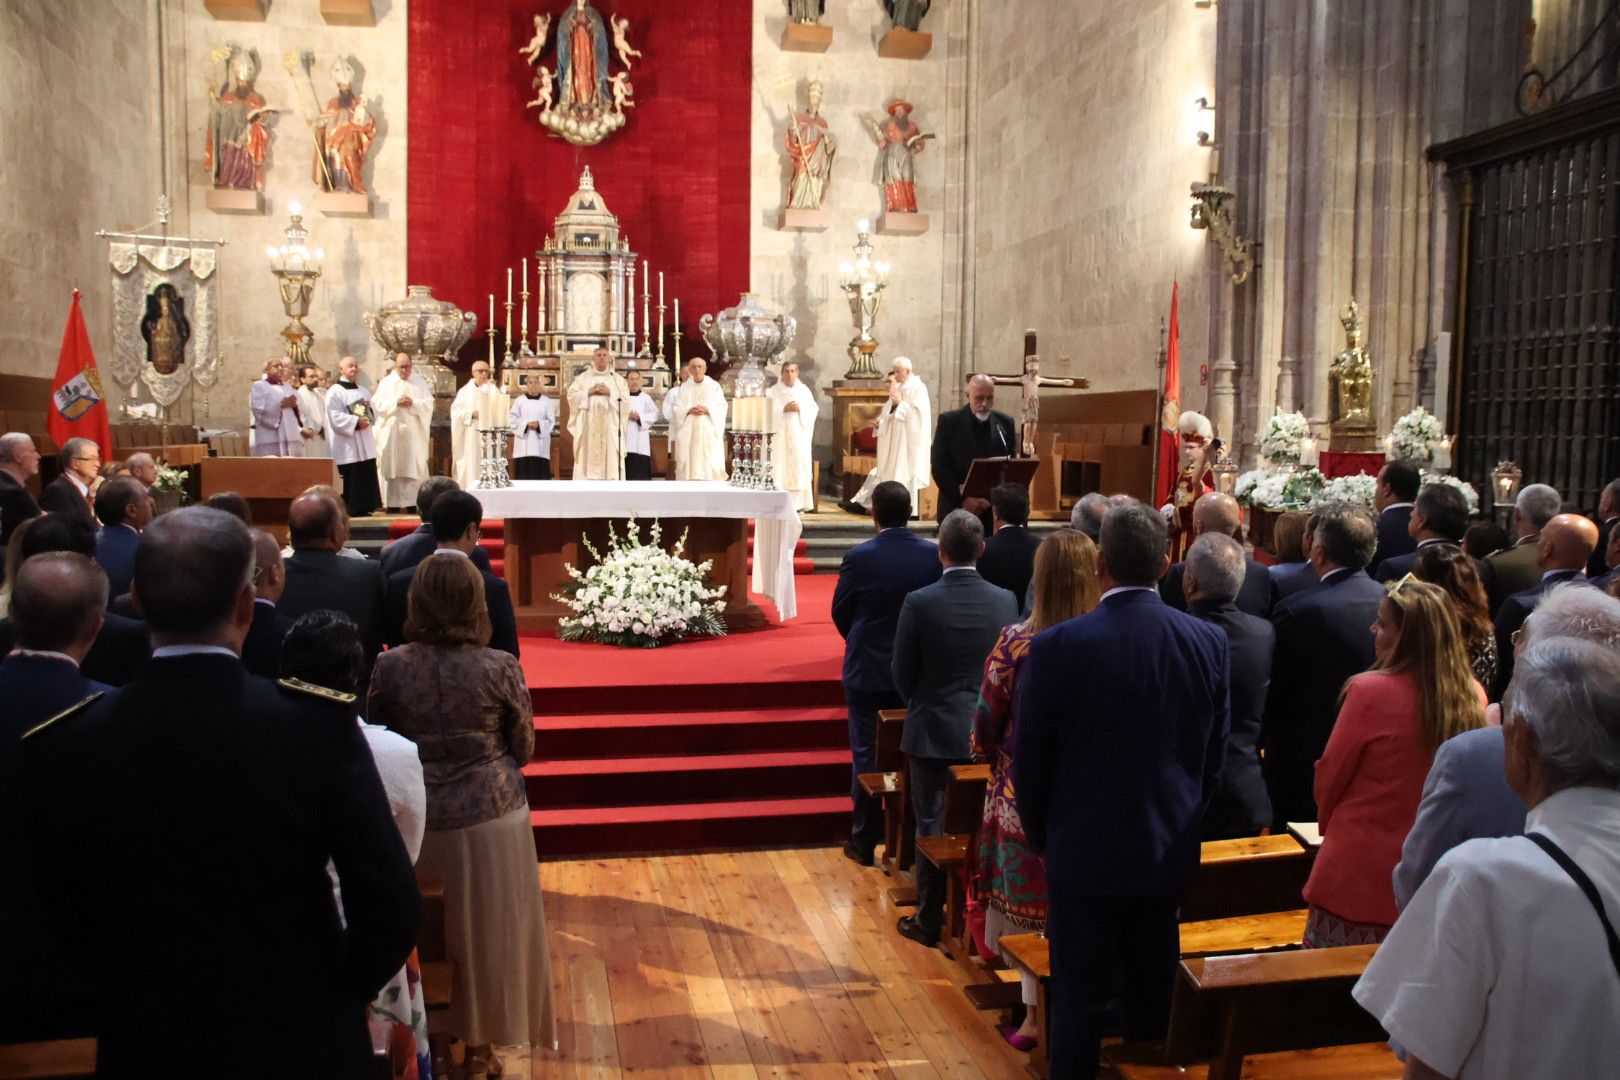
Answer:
1013;507;1230;1077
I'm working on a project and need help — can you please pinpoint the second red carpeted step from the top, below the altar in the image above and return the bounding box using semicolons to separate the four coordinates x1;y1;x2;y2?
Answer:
535;706;849;761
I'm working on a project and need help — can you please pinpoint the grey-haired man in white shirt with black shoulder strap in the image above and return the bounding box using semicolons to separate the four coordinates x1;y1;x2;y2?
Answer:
1353;638;1620;1080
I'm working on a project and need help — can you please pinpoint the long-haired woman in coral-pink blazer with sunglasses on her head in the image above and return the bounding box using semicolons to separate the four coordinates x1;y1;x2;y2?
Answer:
1304;575;1486;949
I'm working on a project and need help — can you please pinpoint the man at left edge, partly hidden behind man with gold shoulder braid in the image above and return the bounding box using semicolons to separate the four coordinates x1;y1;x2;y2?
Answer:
0;552;110;1043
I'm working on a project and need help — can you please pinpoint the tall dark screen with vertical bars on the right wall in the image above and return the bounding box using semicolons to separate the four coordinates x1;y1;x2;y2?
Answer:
1429;91;1620;508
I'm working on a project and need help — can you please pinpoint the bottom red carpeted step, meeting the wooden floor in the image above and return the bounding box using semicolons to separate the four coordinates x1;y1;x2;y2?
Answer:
528;793;849;858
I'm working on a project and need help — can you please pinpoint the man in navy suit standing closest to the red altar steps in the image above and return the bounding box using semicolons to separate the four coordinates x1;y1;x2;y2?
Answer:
833;481;941;866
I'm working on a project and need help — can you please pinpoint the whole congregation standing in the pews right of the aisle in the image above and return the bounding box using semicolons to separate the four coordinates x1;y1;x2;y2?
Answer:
833;437;1620;1078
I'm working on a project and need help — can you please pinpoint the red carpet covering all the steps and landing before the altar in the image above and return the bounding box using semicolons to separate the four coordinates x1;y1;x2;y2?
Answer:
522;575;849;858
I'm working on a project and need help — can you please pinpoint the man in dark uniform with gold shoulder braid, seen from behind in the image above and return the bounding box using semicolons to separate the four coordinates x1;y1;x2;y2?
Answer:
23;507;421;1077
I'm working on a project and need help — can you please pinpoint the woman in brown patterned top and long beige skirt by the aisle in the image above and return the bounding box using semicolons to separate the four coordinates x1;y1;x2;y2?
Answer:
369;549;557;1077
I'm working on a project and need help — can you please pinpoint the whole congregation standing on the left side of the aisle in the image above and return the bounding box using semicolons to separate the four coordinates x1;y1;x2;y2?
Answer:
0;432;556;1077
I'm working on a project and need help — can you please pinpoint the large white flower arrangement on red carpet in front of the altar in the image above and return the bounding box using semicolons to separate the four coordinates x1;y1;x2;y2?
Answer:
552;518;726;649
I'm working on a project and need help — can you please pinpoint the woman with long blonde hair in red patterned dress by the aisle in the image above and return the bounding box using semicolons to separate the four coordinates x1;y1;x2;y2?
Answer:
974;529;1100;1049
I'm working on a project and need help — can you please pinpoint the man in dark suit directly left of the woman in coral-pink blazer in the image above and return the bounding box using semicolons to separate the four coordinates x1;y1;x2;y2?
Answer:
1260;504;1383;826
